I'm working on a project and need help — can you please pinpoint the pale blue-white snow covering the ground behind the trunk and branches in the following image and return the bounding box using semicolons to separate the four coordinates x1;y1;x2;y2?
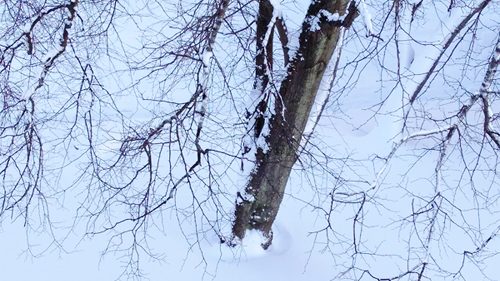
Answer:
0;0;500;281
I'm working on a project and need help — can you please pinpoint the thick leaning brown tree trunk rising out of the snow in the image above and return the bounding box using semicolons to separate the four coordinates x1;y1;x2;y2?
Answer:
233;0;358;248
